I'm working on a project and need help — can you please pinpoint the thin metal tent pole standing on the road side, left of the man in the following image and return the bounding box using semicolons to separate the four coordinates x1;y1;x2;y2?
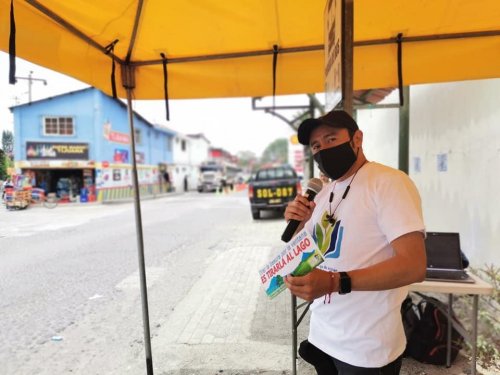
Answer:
121;65;153;375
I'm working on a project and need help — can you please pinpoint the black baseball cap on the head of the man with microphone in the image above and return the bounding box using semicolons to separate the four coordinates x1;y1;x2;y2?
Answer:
297;110;359;146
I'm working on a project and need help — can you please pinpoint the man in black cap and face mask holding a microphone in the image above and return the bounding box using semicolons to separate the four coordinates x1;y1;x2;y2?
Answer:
285;111;426;375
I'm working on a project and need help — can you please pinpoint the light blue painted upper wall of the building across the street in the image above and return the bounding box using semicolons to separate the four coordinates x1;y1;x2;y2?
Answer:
13;89;175;165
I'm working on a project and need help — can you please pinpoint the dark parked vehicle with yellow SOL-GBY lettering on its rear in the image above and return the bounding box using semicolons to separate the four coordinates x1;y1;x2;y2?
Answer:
248;165;302;220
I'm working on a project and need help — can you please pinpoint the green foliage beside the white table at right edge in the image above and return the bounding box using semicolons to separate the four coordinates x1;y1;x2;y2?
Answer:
454;264;500;370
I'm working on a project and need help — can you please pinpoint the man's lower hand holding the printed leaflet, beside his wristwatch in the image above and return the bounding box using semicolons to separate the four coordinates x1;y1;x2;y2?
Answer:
285;268;338;301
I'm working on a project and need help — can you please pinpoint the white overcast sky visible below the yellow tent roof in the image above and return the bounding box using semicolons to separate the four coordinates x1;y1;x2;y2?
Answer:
0;52;316;156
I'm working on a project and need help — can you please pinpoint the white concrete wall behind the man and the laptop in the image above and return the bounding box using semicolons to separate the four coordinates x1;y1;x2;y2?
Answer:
358;79;500;266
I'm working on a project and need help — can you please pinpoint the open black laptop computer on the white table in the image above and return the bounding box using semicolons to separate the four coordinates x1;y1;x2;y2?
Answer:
425;232;474;283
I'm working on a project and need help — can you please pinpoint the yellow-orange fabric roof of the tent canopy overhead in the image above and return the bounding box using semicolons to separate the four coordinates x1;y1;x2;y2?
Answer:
0;0;500;99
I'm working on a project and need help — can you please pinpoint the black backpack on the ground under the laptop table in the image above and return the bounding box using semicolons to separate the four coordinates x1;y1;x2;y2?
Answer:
401;297;464;365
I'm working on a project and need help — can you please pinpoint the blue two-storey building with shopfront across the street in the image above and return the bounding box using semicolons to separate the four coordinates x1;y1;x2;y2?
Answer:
11;88;176;200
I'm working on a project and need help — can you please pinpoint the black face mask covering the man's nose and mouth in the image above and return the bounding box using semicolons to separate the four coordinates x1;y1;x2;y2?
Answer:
314;141;357;180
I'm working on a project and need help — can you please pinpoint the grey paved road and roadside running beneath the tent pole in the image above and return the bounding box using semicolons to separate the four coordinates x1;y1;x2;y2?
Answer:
0;193;476;375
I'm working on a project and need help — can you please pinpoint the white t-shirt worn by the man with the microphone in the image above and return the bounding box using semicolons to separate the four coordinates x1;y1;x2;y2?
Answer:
306;162;424;367
